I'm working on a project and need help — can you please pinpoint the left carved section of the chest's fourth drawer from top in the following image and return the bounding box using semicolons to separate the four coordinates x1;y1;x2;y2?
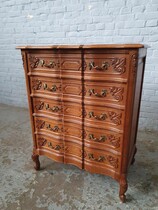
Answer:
34;117;63;138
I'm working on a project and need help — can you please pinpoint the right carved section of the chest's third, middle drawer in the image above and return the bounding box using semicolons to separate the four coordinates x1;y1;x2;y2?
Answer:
84;105;124;132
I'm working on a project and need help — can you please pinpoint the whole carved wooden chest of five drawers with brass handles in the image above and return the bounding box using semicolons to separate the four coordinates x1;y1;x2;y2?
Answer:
17;44;146;202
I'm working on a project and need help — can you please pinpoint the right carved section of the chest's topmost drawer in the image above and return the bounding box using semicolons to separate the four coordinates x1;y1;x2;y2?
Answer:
84;53;129;80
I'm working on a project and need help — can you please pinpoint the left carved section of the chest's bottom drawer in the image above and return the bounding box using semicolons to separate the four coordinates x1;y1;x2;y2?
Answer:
36;134;64;162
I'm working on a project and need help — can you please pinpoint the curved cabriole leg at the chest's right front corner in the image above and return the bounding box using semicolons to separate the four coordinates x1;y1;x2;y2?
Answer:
119;175;128;203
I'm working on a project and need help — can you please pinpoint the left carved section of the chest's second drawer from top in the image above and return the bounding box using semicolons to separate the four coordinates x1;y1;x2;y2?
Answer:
30;76;62;99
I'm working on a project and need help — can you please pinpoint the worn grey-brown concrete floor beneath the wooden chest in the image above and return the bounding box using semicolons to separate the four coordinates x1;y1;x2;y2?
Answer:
0;105;158;210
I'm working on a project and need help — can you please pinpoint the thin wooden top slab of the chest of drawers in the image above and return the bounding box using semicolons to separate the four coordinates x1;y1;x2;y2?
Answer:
16;44;145;49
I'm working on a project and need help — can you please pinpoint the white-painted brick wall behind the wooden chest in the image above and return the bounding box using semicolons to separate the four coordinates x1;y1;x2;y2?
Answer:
0;0;158;130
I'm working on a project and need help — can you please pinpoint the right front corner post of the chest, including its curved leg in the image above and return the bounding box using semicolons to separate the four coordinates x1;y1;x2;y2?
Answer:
119;49;138;203
